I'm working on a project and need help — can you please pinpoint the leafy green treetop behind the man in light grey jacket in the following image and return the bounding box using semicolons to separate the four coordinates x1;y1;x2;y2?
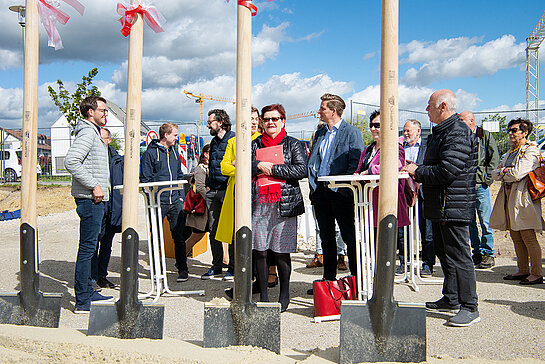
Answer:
47;67;100;132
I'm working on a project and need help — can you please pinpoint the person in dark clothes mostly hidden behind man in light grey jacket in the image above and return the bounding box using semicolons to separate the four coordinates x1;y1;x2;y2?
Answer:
91;128;124;288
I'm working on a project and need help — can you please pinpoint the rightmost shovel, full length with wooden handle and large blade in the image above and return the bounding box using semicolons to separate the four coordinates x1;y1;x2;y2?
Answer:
340;0;426;363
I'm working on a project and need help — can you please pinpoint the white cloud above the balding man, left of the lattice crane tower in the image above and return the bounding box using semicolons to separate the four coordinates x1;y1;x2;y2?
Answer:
400;35;525;85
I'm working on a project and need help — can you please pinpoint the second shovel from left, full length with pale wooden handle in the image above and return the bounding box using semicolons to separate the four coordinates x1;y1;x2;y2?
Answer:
87;7;164;339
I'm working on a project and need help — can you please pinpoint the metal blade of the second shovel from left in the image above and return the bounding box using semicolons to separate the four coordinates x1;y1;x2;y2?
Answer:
87;302;165;339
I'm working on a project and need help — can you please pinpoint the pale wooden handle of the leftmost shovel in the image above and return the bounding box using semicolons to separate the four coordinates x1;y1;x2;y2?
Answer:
21;0;39;229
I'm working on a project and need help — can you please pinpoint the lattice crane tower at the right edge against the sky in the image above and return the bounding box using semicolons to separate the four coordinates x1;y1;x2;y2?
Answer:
526;13;545;138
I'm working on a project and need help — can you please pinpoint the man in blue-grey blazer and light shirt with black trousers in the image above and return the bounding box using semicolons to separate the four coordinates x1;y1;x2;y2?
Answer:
308;94;364;288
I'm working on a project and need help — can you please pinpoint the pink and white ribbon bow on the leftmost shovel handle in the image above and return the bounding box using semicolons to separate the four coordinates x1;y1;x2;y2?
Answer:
38;0;85;50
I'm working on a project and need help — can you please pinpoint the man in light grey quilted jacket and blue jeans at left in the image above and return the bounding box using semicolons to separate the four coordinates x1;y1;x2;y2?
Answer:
64;96;113;313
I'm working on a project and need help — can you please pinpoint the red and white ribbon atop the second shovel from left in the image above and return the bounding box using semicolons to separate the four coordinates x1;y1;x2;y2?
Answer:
117;0;166;37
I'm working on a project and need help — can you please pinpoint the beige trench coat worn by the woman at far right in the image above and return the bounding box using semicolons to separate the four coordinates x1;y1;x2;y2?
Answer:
490;142;544;232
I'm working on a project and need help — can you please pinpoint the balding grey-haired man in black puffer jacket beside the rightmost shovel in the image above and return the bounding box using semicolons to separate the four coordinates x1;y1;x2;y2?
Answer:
403;90;481;326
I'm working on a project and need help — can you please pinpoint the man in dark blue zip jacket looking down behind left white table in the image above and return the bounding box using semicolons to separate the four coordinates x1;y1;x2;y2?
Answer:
140;123;189;282
